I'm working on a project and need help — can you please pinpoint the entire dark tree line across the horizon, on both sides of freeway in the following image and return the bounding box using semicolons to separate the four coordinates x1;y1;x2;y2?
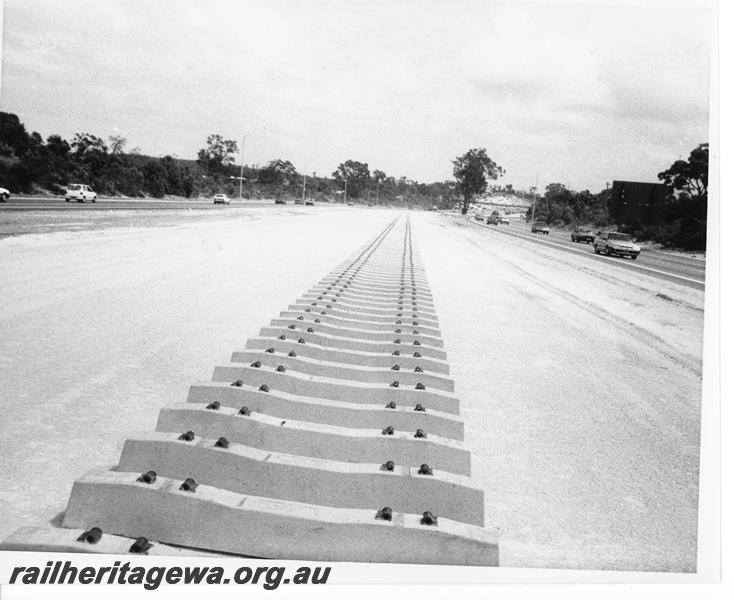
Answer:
0;112;708;250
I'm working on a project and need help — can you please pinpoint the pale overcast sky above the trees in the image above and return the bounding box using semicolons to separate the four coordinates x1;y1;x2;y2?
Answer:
0;0;712;191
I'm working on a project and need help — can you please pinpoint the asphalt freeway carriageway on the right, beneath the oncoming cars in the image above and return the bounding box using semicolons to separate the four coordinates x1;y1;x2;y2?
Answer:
471;219;706;290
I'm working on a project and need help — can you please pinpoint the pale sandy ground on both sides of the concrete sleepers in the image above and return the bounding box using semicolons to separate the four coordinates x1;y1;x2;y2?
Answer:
0;207;703;571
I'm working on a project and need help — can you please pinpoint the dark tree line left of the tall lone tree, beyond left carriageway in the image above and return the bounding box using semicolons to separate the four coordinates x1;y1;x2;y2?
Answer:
0;112;454;207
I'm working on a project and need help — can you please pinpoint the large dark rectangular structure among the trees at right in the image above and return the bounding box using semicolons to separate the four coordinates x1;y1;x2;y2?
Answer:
609;181;668;225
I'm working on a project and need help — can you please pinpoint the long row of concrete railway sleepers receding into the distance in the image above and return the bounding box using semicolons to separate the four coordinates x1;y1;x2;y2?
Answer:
0;217;499;566
